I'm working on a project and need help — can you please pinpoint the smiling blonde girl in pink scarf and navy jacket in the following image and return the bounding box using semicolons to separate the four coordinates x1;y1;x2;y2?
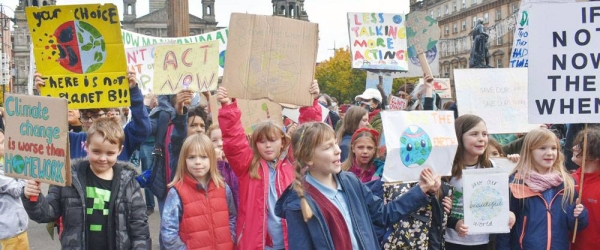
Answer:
497;129;588;250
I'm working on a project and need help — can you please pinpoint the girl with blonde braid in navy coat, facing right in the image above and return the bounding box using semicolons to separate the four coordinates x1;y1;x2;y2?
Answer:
275;122;440;250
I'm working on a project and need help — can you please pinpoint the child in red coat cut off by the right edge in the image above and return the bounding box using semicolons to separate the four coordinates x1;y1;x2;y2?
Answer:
571;127;600;250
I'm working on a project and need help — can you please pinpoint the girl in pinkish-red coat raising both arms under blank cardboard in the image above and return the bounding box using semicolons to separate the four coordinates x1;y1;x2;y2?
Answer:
217;82;321;250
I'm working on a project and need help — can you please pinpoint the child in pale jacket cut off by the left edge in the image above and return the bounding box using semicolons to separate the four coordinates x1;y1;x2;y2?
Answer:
0;129;29;250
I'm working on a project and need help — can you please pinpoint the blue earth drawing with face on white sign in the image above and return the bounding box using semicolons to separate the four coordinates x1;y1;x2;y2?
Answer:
400;125;432;168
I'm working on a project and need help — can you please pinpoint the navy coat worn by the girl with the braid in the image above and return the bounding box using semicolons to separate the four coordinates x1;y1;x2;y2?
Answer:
275;171;429;250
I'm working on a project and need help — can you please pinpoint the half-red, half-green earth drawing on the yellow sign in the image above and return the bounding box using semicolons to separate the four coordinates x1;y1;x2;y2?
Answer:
54;21;106;74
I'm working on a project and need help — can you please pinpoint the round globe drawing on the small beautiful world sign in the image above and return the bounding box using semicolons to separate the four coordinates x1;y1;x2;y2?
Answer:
469;186;502;220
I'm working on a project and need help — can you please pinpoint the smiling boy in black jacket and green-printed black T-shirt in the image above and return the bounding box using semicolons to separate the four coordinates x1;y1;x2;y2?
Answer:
21;118;151;249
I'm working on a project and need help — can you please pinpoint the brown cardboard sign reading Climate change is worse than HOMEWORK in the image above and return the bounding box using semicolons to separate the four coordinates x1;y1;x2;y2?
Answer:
4;93;71;186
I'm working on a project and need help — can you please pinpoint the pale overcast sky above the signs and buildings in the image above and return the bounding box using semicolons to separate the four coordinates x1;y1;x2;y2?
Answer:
0;0;409;61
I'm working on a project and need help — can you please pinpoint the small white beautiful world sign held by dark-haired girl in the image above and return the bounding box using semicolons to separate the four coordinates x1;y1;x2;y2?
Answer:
463;168;510;234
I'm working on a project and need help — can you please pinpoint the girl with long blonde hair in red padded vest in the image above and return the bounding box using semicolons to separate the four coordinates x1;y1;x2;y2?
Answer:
160;134;236;249
